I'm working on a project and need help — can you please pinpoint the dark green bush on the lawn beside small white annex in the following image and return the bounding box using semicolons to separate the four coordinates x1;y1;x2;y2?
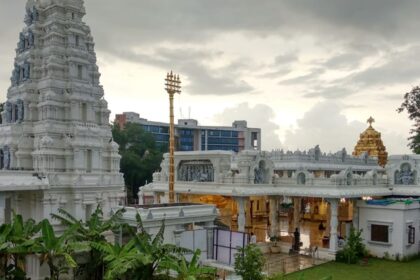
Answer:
336;227;367;264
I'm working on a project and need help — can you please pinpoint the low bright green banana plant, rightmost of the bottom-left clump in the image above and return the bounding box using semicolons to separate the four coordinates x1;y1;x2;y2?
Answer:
161;249;216;280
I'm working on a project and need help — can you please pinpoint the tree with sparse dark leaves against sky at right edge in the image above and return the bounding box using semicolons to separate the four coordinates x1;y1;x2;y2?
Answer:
397;86;420;154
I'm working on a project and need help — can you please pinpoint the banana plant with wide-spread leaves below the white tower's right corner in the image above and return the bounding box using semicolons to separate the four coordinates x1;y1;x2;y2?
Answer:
51;205;125;280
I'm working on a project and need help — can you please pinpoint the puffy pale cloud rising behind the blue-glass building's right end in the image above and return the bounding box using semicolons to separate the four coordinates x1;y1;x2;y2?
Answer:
213;102;281;150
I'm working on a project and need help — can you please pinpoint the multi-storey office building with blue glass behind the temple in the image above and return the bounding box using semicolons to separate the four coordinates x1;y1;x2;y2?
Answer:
115;112;261;152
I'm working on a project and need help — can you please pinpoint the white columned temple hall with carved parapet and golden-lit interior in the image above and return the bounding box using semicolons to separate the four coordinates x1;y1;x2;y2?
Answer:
139;146;420;259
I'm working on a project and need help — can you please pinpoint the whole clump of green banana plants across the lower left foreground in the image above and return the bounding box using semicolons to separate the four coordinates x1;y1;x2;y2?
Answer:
0;207;215;280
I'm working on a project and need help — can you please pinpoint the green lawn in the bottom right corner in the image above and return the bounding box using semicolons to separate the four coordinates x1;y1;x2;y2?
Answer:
284;259;420;280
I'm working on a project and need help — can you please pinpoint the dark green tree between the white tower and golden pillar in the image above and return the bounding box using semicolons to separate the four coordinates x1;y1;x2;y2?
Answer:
112;123;166;198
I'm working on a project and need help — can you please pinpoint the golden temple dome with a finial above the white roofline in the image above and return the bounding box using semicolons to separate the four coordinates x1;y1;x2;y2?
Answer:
353;117;388;167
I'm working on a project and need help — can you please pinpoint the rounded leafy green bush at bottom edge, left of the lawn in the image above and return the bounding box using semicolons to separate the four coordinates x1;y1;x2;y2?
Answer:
235;244;265;280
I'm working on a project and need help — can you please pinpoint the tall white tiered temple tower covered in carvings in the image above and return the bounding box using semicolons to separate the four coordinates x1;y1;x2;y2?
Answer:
0;0;125;224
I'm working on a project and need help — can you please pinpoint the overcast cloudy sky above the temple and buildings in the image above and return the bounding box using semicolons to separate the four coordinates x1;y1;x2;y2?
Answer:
0;0;420;154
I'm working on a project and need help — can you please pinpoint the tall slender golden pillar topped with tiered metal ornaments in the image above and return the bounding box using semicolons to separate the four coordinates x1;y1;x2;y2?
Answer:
165;71;181;203
